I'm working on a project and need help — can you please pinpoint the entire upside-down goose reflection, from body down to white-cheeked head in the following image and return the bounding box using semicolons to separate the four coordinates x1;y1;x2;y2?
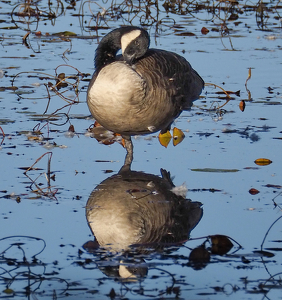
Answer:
84;155;203;280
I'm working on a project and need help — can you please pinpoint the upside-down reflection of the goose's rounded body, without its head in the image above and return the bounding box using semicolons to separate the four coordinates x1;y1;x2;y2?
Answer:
86;168;203;252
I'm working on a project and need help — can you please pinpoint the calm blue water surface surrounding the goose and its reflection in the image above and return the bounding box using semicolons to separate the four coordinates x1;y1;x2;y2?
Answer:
0;1;282;299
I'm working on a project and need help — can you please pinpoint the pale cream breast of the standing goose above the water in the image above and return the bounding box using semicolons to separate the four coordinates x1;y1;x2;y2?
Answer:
87;61;144;132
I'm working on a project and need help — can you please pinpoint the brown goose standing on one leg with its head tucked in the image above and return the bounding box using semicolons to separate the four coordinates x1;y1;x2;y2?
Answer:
87;26;204;159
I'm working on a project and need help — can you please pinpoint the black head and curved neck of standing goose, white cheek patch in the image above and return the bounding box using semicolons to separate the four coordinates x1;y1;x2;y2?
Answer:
95;26;150;72
